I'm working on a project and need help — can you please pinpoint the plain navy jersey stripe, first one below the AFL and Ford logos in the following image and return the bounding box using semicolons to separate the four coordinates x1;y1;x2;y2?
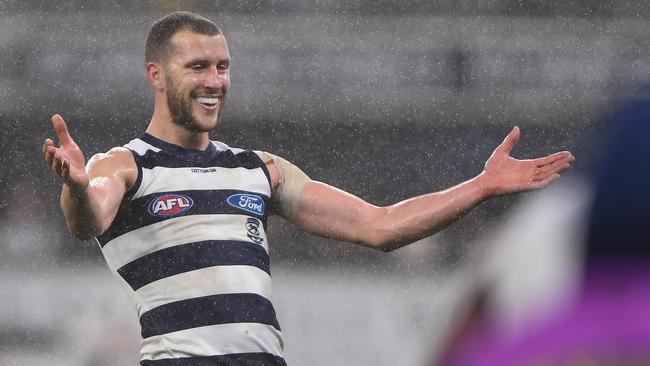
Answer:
117;240;271;291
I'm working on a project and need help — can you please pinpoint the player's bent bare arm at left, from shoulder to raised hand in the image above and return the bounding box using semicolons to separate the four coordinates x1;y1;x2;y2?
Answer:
43;114;137;240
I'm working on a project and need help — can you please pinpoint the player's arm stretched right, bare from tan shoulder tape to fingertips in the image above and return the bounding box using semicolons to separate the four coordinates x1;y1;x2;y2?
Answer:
276;127;574;251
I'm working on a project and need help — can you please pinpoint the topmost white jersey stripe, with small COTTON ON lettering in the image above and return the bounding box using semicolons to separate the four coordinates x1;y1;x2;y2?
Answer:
133;166;271;199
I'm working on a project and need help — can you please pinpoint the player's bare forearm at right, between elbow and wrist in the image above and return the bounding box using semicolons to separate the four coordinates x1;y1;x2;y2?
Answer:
369;175;492;251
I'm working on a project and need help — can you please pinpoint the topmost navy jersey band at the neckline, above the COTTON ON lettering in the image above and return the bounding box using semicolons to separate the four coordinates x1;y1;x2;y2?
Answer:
137;150;262;169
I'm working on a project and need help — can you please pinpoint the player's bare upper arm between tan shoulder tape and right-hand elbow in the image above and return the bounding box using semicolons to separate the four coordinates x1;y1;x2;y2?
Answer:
290;181;381;246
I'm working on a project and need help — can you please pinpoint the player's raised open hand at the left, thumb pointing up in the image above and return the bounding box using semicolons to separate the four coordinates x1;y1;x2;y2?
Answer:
43;114;89;192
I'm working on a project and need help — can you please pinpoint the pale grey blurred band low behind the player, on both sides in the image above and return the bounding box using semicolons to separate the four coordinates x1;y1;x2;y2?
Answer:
0;266;466;366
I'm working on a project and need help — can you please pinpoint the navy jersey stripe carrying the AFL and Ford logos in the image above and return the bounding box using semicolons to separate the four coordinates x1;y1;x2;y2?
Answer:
97;189;269;247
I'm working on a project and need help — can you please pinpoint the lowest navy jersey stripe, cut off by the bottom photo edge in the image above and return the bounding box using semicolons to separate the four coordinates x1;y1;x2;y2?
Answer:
140;353;287;366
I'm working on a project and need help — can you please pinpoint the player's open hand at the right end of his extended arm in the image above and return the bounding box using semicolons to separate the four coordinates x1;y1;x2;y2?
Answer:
483;127;575;195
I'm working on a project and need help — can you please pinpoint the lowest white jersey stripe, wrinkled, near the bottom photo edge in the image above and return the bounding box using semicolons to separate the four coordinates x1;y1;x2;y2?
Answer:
140;323;284;360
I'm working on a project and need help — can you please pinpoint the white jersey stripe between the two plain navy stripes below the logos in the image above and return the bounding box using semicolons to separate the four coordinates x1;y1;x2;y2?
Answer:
135;265;273;317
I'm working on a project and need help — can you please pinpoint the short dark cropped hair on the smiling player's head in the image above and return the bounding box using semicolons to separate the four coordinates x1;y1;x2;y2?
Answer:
144;11;221;63
